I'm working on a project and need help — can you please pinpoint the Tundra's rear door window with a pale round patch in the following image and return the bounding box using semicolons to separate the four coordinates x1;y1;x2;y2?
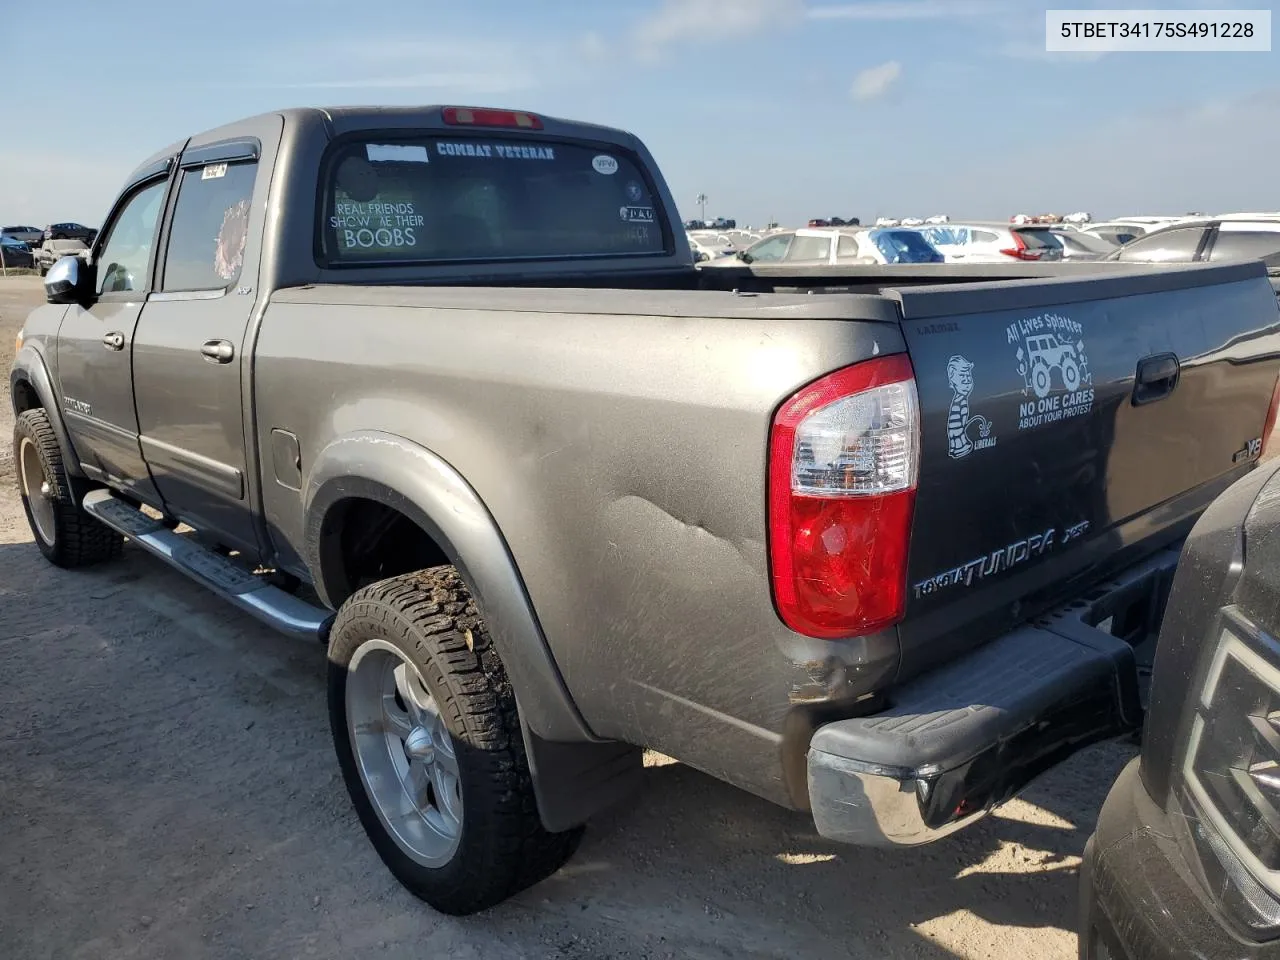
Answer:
160;161;257;291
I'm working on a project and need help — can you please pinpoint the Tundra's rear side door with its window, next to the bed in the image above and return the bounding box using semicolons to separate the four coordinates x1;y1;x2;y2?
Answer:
133;141;261;554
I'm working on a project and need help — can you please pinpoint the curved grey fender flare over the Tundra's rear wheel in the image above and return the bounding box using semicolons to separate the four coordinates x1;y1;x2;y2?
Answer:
301;430;596;742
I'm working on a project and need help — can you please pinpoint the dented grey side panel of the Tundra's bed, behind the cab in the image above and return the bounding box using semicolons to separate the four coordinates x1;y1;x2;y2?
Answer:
256;288;904;800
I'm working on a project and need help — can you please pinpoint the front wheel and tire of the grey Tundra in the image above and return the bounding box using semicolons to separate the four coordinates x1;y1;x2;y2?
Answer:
13;410;124;568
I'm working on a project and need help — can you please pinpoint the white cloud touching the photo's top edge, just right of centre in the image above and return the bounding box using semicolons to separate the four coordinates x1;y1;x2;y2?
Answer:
631;0;804;59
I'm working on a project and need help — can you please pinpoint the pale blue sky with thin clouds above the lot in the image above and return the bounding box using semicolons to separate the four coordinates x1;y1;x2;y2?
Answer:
0;0;1280;224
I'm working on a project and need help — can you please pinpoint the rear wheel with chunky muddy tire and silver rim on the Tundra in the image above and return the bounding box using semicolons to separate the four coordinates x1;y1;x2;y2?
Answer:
329;567;582;915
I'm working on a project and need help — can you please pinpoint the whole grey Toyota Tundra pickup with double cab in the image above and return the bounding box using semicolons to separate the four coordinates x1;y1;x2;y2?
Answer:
9;108;1280;914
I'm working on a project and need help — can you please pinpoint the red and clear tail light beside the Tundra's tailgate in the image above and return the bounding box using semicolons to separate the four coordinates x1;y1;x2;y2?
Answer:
769;355;919;639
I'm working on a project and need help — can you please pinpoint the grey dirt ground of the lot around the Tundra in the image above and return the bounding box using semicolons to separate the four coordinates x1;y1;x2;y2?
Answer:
0;278;1133;960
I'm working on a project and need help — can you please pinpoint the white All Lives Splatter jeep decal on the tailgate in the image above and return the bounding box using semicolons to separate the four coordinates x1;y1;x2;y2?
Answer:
1005;314;1093;430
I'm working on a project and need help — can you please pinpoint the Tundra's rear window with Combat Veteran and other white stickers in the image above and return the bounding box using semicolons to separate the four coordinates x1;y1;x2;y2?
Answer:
321;134;667;264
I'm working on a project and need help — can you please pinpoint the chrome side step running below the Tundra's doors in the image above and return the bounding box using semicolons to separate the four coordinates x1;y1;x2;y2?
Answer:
84;490;333;640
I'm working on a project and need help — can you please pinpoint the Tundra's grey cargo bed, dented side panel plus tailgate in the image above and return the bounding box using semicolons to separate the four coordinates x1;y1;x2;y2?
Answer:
255;256;1280;801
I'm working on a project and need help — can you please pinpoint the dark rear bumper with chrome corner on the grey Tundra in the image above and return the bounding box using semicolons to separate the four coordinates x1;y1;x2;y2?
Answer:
808;549;1178;846
